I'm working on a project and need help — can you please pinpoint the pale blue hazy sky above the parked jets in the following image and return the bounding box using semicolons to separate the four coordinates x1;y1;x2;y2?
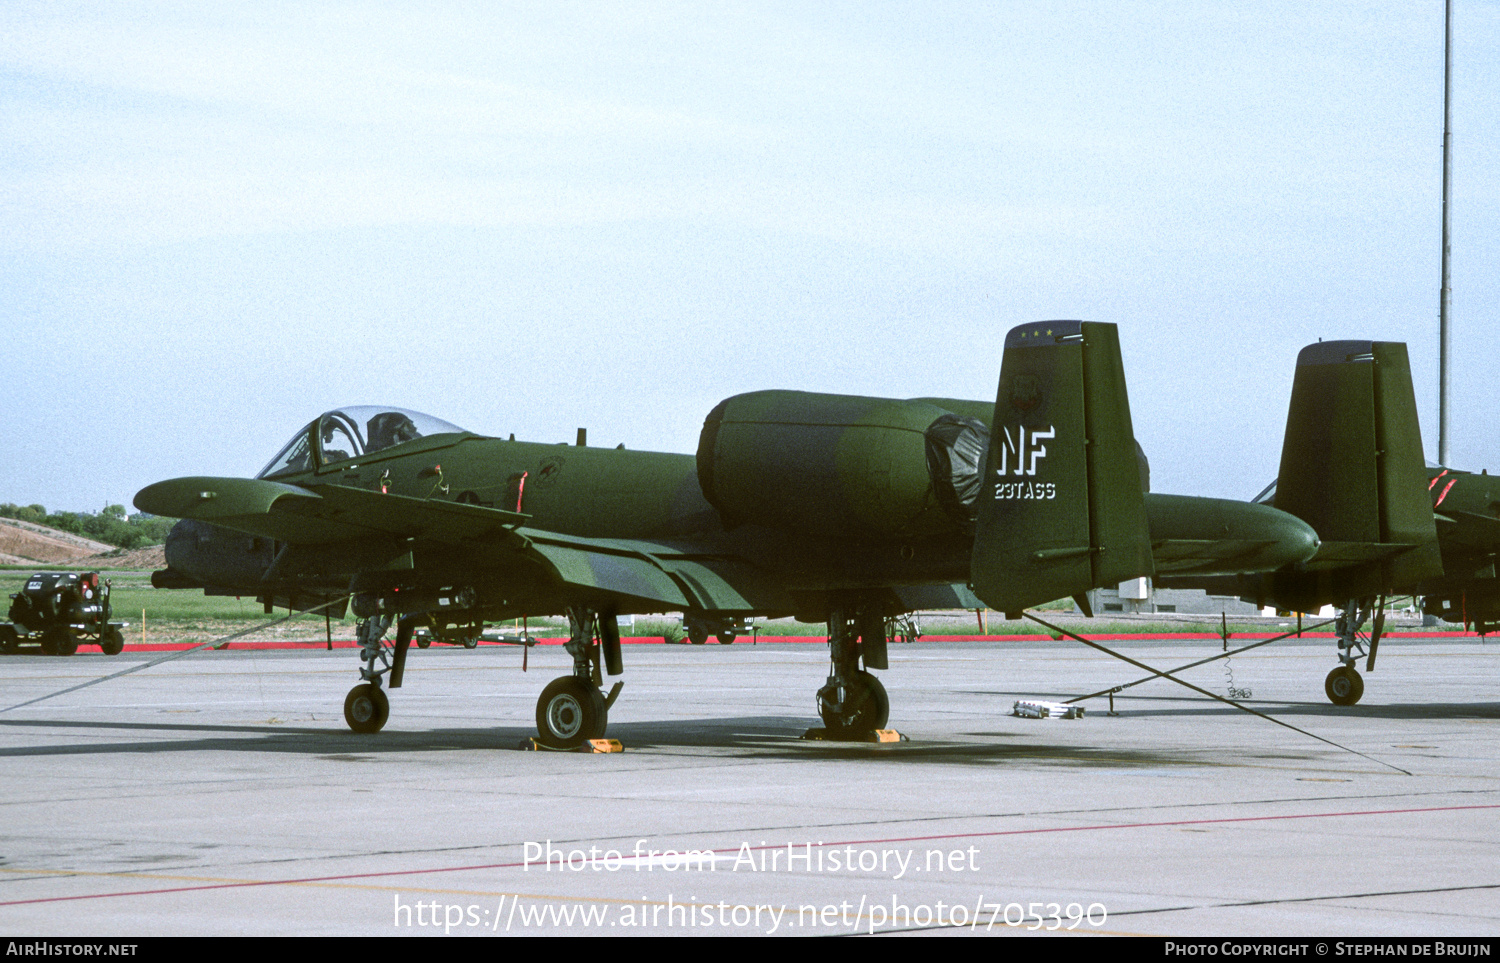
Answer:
0;0;1500;510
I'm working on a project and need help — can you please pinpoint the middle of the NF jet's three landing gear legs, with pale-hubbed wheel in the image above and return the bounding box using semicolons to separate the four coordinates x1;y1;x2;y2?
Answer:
537;608;624;749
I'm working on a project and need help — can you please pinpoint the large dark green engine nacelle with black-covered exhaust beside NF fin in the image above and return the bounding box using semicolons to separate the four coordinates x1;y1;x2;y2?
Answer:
698;392;989;537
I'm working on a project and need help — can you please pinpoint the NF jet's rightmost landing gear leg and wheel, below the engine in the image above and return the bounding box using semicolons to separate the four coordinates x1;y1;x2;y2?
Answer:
818;606;891;740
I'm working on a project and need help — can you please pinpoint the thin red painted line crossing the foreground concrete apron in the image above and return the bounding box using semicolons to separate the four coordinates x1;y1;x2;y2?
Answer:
0;804;1500;906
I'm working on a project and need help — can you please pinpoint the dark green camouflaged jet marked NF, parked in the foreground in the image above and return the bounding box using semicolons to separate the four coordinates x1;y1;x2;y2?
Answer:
135;321;1317;749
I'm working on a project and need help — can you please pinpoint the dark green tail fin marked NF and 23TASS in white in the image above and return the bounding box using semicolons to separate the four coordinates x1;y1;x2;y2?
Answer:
971;321;1154;612
